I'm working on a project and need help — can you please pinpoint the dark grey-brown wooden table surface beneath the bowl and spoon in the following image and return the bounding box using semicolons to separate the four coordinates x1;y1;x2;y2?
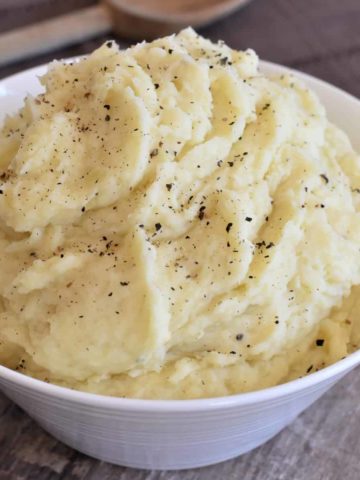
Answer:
0;0;360;480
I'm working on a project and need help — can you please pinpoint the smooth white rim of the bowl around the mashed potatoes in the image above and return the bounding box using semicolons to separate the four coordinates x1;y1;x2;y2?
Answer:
0;56;360;413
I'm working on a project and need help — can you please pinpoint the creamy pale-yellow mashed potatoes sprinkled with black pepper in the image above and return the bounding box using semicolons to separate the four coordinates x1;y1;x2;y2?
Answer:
0;29;360;399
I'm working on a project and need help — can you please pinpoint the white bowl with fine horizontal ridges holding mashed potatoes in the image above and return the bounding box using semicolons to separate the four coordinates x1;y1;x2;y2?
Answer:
0;62;360;469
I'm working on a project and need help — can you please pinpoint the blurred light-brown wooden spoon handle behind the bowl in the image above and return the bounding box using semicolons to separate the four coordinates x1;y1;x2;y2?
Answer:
0;5;111;66
